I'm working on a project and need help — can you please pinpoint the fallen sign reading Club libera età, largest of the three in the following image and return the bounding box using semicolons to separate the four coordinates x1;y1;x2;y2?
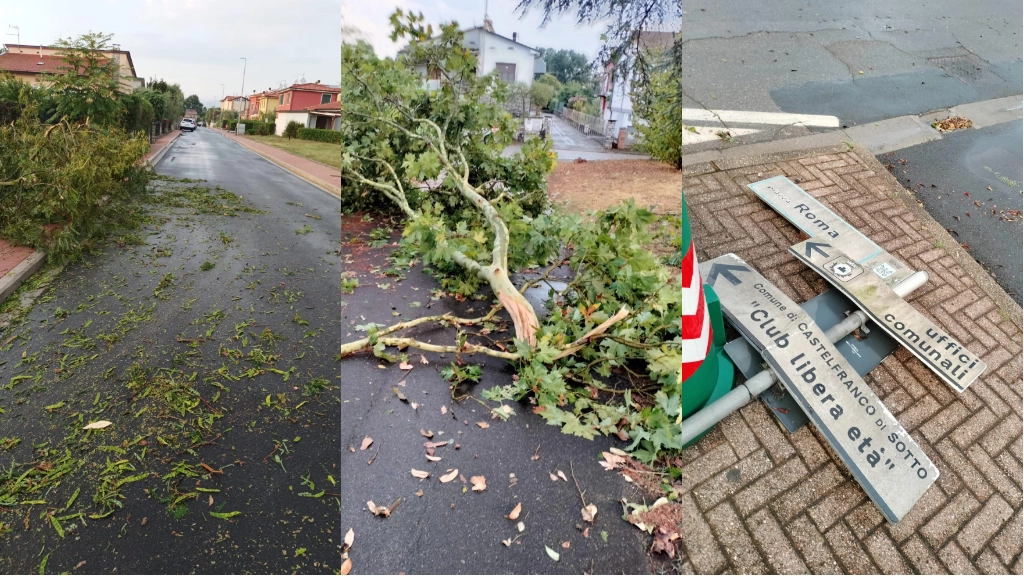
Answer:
700;254;939;523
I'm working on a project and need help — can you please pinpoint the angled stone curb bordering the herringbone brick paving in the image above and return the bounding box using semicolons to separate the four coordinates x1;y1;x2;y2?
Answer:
683;142;1024;329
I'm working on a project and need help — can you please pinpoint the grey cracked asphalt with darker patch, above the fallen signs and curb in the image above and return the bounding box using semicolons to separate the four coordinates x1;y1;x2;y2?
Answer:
683;0;1022;154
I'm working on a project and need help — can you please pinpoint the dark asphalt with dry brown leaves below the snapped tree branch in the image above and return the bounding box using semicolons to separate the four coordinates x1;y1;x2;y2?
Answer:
341;216;651;574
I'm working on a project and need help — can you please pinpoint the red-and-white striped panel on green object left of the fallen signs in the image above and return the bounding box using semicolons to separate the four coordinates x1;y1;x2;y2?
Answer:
682;198;712;381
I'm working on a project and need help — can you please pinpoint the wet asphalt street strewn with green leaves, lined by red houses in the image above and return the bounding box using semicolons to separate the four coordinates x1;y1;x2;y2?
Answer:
0;129;342;574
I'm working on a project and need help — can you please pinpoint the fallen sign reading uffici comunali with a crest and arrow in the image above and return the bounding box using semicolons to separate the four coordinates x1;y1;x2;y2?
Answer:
790;240;987;393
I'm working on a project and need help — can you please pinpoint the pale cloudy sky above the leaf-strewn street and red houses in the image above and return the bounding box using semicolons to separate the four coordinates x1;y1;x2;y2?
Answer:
0;0;341;107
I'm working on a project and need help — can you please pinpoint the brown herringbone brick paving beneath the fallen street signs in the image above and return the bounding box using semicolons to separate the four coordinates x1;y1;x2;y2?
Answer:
682;148;1024;574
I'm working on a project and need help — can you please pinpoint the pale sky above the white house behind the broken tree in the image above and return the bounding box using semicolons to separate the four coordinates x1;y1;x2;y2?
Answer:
341;0;605;59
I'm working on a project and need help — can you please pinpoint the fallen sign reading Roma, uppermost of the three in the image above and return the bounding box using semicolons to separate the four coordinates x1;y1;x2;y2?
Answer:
748;176;913;286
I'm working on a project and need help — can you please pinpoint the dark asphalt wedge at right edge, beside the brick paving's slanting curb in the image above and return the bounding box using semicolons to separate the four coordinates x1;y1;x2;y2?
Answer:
878;122;1024;304
